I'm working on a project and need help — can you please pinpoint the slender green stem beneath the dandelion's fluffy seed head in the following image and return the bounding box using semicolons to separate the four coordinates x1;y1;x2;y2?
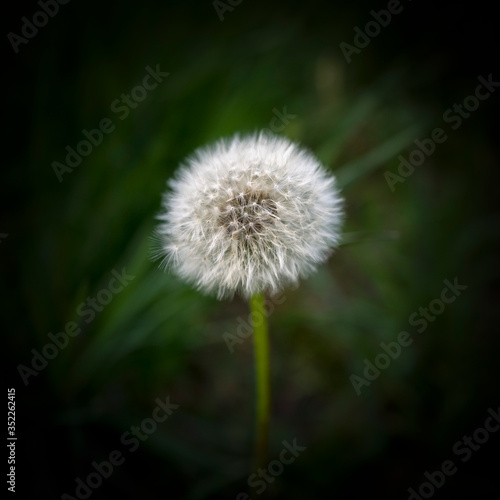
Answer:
250;293;271;467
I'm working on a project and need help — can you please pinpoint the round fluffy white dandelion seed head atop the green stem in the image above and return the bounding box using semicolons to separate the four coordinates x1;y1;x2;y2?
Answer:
156;133;342;299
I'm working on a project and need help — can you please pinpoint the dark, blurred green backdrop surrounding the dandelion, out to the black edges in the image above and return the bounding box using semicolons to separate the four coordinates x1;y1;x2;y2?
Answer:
0;0;500;500
